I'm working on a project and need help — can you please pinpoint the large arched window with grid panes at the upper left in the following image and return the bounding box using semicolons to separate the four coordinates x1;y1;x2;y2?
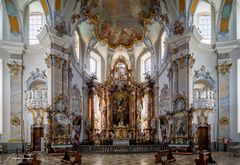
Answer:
28;1;45;45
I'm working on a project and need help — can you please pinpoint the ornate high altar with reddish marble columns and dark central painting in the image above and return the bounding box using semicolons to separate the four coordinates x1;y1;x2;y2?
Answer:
86;57;155;144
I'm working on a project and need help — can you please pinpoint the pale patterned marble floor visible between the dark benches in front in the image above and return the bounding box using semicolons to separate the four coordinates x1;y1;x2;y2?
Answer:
0;152;240;165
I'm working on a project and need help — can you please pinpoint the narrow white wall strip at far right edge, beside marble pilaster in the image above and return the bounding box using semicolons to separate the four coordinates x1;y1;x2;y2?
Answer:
230;48;240;142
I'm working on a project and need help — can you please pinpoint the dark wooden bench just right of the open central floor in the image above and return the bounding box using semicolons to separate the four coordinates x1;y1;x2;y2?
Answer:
155;149;176;165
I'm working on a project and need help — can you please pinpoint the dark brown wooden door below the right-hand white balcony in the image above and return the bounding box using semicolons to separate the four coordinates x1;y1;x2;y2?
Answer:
197;127;209;150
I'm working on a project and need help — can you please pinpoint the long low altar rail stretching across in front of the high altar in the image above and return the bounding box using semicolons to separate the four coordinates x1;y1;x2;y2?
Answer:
75;145;164;153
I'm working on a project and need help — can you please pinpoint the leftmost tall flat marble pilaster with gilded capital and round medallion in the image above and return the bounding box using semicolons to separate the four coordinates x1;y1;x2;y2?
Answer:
7;59;24;143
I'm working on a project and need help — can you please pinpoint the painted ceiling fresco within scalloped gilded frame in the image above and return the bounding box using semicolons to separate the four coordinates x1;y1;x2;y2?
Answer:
83;0;158;48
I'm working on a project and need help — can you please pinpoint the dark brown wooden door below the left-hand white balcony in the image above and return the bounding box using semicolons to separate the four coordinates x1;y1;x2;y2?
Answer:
32;127;44;151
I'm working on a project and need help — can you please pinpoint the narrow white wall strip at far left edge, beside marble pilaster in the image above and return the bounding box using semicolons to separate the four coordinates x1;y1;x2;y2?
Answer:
0;49;10;143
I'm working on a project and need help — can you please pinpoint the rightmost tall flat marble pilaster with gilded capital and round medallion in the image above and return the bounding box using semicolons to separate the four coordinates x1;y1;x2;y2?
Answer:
217;54;232;140
